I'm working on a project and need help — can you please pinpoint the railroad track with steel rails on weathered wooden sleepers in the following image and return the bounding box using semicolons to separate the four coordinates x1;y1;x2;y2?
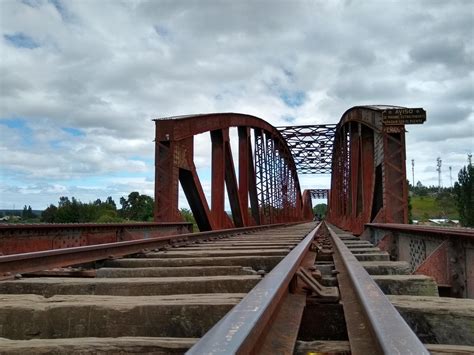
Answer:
0;223;474;354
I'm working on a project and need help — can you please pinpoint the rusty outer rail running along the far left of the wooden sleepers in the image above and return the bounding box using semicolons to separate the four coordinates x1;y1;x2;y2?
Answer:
0;223;288;280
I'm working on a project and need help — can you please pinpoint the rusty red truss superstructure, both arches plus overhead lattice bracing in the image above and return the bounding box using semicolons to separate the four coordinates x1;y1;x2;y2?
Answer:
155;106;425;235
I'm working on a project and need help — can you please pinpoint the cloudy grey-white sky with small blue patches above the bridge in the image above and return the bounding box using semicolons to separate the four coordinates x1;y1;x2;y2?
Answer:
0;0;474;209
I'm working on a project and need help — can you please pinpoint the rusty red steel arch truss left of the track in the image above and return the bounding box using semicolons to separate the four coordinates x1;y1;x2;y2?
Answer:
154;113;303;231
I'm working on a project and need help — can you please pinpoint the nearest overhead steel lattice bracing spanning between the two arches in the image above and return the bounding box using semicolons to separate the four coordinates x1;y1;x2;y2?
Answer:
277;124;336;174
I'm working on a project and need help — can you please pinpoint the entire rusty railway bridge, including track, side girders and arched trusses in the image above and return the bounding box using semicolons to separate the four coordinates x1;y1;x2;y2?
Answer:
0;106;474;354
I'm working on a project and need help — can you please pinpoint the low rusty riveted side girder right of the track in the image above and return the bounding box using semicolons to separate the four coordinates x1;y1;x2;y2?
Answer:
361;223;474;298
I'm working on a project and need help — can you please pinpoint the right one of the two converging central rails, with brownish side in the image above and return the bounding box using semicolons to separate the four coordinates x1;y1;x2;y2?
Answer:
326;224;429;355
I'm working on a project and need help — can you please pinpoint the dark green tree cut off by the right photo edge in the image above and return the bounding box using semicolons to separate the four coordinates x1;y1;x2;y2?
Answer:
454;159;474;227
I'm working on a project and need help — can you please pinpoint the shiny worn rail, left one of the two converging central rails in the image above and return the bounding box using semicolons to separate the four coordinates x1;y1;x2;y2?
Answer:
186;224;321;355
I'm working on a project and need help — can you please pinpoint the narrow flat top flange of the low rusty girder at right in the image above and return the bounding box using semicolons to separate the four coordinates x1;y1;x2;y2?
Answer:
365;223;474;239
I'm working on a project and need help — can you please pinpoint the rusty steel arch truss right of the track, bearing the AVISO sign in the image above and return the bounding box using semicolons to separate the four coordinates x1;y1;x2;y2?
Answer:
326;105;426;234
